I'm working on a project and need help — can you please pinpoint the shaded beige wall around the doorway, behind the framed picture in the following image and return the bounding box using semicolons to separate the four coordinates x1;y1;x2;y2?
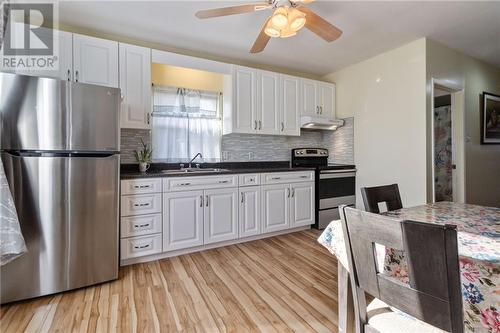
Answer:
426;40;500;207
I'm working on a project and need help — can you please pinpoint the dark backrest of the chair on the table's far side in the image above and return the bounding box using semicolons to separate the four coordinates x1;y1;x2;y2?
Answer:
361;184;403;214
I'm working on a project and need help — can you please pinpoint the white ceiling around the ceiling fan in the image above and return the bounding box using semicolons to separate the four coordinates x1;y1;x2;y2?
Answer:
59;1;500;75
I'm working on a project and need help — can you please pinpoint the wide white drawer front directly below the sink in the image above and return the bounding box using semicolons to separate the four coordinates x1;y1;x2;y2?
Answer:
163;175;238;192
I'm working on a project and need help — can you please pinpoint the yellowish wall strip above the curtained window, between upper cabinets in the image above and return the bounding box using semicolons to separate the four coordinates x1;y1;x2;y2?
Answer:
151;64;224;92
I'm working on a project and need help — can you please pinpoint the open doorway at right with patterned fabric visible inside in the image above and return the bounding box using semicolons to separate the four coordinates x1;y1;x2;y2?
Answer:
432;81;465;202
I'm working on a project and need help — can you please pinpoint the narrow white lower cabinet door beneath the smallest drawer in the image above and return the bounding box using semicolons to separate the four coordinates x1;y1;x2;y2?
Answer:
239;186;261;237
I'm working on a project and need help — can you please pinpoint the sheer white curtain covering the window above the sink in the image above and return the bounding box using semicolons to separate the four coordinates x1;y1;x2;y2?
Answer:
152;86;222;162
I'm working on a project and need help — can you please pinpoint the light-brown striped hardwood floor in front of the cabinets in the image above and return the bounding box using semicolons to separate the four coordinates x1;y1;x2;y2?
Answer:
0;230;338;333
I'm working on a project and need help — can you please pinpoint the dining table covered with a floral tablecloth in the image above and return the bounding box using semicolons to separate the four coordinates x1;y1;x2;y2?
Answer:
318;202;500;333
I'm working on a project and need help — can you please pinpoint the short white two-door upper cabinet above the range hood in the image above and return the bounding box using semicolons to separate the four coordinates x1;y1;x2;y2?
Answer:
301;79;335;119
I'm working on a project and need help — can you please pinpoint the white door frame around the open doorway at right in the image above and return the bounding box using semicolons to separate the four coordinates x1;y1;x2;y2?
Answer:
431;78;466;202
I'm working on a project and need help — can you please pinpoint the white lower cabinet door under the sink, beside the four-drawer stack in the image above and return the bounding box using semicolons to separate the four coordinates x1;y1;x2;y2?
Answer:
163;191;203;251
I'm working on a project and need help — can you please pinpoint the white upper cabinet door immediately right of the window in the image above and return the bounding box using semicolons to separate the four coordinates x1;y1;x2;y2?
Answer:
233;66;258;133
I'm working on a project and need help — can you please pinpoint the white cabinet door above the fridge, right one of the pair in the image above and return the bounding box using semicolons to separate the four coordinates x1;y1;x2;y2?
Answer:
73;34;118;88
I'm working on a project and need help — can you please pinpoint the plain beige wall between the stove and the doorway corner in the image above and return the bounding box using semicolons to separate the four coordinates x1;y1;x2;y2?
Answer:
324;39;426;207
